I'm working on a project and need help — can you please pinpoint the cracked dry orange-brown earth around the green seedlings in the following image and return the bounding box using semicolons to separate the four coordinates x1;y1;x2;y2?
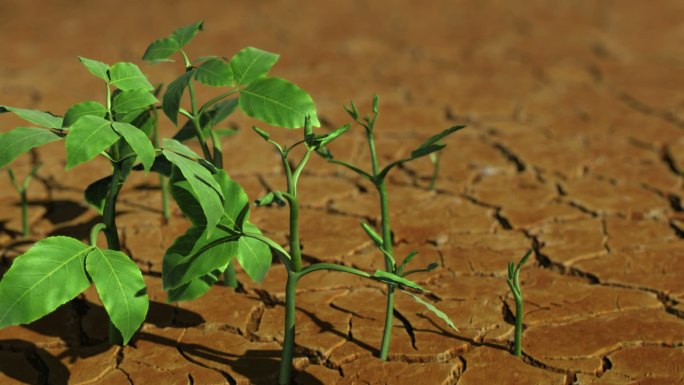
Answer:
0;0;684;385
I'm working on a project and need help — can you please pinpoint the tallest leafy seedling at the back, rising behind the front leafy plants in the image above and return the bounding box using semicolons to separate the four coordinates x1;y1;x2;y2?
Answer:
143;21;318;288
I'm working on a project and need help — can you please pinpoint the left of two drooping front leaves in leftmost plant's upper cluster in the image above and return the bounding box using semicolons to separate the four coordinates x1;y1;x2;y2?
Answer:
66;115;119;170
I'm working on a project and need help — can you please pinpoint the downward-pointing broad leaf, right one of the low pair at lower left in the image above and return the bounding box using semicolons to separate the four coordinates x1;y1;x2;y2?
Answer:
86;247;149;345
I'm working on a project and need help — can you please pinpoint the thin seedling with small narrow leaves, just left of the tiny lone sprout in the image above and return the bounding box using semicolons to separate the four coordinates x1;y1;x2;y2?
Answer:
318;95;465;360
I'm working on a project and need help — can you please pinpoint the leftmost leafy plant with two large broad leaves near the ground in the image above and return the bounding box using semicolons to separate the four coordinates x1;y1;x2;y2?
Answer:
0;58;156;343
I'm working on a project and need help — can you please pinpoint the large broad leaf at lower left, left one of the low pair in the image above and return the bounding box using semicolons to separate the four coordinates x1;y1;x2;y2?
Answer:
0;237;91;328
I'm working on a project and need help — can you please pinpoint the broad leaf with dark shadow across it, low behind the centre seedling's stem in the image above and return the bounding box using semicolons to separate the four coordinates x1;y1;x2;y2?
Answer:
162;226;239;290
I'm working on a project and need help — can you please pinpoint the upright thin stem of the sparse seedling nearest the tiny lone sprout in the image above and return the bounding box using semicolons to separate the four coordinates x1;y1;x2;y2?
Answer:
366;126;395;361
